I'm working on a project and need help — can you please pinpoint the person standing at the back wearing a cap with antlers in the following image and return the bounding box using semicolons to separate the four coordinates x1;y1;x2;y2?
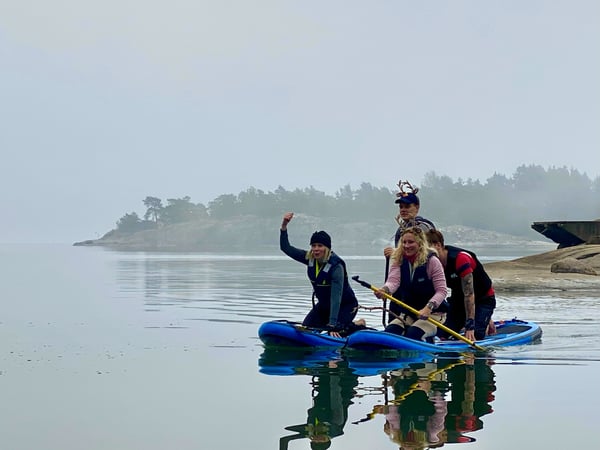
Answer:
383;180;435;321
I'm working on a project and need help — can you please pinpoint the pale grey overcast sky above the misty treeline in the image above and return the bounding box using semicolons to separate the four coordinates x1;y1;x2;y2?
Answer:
0;0;600;243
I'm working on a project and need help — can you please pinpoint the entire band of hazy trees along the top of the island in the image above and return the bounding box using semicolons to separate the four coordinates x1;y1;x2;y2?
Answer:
114;165;600;243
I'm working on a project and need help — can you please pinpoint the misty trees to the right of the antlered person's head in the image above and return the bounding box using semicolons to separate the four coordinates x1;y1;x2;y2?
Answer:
421;165;600;236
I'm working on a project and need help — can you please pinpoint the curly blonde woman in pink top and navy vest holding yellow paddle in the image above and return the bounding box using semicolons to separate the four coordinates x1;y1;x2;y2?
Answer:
375;227;448;340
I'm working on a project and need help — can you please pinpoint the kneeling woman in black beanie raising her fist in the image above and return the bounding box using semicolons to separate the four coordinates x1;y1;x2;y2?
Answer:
279;212;358;333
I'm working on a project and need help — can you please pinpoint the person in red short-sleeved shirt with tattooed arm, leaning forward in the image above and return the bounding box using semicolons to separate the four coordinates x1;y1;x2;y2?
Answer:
427;230;496;341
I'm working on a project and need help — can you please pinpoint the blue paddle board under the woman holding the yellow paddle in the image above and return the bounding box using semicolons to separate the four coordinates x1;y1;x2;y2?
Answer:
346;319;542;353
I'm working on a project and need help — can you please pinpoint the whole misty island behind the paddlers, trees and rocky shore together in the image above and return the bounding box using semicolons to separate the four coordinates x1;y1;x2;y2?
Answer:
75;165;600;254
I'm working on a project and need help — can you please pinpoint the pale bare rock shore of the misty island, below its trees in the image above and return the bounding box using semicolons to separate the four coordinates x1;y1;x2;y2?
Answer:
73;215;553;255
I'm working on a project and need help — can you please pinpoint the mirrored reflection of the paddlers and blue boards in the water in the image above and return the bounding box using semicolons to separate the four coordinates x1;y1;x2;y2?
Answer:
259;349;496;450
